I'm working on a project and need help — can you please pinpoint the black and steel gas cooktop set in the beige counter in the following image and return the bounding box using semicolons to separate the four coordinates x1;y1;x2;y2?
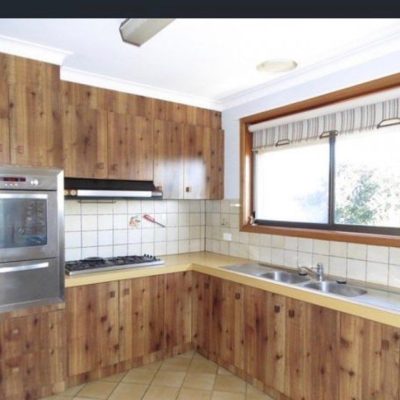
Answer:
65;254;164;275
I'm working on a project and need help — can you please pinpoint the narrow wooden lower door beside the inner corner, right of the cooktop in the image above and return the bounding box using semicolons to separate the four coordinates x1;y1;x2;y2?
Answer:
164;271;192;356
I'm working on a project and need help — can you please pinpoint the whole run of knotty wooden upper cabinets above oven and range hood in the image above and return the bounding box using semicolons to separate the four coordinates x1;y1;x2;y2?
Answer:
0;53;224;199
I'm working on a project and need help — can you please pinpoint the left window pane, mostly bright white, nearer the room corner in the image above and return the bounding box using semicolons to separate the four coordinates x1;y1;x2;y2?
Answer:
255;140;329;224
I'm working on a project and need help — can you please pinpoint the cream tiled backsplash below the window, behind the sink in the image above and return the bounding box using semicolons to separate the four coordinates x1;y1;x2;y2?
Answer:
206;200;400;288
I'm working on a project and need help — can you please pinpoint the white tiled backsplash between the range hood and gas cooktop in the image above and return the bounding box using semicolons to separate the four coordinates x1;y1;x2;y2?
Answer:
65;200;205;261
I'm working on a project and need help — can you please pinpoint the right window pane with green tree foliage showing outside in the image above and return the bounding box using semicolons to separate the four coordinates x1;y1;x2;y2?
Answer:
335;126;400;227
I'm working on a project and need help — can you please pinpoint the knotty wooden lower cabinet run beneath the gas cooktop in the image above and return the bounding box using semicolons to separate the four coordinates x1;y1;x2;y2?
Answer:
66;272;192;385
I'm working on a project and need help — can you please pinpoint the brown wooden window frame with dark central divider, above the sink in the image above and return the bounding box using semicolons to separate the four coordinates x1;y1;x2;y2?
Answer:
240;73;400;247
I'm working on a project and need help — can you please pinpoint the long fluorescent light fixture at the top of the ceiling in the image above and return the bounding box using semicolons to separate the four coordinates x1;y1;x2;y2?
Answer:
119;18;174;46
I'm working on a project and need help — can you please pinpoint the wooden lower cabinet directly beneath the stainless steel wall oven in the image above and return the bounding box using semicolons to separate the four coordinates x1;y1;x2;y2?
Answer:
0;310;66;400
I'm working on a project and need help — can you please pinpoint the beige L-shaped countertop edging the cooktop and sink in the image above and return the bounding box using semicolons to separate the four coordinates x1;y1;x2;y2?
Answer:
65;252;400;327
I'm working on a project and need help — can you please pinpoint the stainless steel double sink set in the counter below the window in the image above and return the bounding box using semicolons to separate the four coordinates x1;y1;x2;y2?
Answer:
225;264;367;297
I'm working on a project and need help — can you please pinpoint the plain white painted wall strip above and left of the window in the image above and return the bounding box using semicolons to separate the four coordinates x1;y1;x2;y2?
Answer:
222;52;400;199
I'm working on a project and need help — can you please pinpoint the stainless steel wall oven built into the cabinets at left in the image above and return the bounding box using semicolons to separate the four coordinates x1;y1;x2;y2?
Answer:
0;166;64;311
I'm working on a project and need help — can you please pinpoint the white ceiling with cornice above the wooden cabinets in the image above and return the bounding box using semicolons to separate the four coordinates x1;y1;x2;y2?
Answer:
0;19;400;109
